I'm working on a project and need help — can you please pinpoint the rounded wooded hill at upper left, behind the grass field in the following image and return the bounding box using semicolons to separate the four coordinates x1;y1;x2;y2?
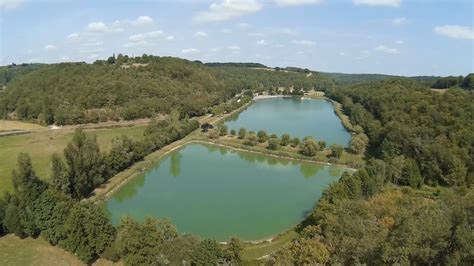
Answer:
0;55;322;125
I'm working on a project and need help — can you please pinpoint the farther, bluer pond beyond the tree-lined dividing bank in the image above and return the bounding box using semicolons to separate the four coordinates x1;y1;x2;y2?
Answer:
225;98;351;146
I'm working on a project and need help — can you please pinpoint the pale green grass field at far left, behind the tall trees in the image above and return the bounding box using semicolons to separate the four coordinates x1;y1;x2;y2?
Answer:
0;125;145;195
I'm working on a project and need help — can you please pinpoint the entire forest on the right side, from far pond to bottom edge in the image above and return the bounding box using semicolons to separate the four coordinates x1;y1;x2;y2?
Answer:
268;79;474;265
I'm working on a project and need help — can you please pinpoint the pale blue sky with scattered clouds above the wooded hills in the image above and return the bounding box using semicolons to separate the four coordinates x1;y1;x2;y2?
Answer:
0;0;474;76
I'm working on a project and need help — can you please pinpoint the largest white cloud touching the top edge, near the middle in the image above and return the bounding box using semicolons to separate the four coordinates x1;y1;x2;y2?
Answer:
194;0;262;22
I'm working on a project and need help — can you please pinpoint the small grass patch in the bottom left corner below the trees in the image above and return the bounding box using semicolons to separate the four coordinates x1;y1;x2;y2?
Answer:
0;235;118;266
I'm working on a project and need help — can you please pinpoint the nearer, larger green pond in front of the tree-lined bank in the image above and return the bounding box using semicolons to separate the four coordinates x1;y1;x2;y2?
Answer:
104;143;345;241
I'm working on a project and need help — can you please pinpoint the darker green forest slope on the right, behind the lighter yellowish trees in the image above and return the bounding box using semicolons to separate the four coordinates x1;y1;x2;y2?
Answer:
328;80;474;186
